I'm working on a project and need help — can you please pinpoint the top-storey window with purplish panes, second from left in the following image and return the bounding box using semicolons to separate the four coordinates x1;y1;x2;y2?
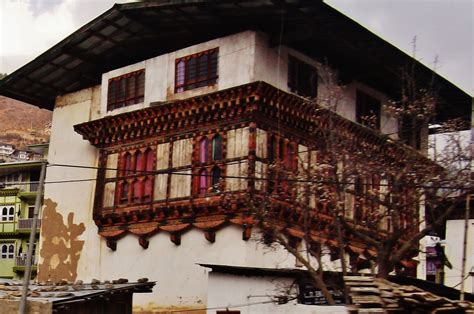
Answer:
175;48;219;93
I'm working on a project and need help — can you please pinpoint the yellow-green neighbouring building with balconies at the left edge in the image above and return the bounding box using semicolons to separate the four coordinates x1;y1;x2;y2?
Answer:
0;144;47;279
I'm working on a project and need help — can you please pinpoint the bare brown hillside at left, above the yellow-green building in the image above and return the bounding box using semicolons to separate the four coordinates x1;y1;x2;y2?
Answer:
0;96;53;149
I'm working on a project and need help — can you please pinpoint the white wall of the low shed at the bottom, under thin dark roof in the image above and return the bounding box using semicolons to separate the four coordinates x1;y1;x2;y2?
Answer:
207;271;348;314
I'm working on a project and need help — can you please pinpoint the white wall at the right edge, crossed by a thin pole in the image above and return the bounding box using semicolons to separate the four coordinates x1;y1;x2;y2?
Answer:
444;219;474;293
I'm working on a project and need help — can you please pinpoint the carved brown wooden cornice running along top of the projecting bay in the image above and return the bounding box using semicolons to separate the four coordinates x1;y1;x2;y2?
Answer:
74;82;429;164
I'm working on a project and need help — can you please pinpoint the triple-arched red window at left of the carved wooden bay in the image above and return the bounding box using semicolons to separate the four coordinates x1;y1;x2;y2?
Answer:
118;148;155;205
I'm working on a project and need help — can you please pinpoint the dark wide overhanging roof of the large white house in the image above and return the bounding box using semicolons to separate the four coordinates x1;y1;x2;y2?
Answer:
0;0;471;119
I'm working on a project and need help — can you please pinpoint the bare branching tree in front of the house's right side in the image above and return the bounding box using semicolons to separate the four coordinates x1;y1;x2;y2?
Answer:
237;63;470;304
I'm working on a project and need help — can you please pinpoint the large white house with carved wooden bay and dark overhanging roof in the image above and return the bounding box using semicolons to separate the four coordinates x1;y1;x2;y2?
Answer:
0;0;470;312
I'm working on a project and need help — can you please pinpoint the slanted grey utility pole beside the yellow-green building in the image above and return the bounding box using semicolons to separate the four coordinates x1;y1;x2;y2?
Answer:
20;160;47;314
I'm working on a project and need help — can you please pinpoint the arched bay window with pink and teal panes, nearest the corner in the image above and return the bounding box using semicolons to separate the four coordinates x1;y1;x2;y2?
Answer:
197;134;223;194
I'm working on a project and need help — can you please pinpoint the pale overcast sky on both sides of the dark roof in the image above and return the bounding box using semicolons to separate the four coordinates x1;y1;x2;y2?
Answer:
0;0;474;95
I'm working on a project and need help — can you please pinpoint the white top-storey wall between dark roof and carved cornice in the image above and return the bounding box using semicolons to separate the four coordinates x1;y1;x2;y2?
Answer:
101;31;398;133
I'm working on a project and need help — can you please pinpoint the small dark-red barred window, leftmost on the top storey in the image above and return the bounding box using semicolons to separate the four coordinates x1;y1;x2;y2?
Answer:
107;70;145;111
